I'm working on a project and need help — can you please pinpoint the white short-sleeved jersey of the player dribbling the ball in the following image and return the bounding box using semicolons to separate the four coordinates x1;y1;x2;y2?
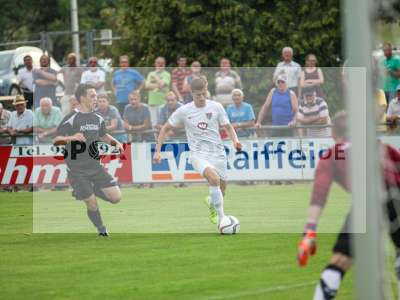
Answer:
168;100;229;158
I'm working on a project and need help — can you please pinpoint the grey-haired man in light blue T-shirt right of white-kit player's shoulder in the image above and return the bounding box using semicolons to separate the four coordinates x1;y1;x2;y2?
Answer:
226;89;256;137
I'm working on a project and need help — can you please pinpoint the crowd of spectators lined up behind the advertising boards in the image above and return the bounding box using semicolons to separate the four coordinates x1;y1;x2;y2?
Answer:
0;44;400;145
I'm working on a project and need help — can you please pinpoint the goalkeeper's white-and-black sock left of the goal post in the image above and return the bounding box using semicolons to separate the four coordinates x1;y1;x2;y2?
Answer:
313;265;343;300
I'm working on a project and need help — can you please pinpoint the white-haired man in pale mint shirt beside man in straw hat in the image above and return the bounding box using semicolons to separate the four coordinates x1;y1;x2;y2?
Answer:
33;97;63;143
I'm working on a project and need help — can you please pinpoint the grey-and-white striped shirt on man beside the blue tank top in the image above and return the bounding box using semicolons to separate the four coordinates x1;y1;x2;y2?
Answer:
299;97;331;137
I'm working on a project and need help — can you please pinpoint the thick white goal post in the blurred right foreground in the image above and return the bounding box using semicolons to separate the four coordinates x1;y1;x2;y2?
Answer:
342;0;385;300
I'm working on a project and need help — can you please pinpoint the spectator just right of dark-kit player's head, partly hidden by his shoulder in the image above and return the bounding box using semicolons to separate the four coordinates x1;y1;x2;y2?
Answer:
96;94;128;143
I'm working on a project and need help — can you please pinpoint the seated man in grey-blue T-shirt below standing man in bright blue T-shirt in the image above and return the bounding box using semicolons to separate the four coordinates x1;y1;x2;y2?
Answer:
123;91;154;142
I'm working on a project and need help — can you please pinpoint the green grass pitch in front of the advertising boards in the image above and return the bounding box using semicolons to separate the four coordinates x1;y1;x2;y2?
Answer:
0;184;354;300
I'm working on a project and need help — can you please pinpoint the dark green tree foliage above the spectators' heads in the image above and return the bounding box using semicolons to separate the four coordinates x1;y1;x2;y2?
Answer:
108;0;341;66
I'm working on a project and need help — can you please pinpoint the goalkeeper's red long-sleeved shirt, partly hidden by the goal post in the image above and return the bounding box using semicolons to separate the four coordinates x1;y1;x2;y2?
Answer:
311;143;400;206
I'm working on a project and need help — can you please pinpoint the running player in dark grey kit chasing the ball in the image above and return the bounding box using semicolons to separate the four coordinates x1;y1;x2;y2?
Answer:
53;84;124;236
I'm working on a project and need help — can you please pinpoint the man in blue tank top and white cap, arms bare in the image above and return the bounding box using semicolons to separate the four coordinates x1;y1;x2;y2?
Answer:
256;75;298;137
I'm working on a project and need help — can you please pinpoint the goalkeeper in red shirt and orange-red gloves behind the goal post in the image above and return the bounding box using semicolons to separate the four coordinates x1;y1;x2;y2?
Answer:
297;112;400;300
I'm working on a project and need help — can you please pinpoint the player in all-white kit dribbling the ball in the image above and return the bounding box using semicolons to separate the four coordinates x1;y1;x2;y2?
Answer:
154;78;242;224
